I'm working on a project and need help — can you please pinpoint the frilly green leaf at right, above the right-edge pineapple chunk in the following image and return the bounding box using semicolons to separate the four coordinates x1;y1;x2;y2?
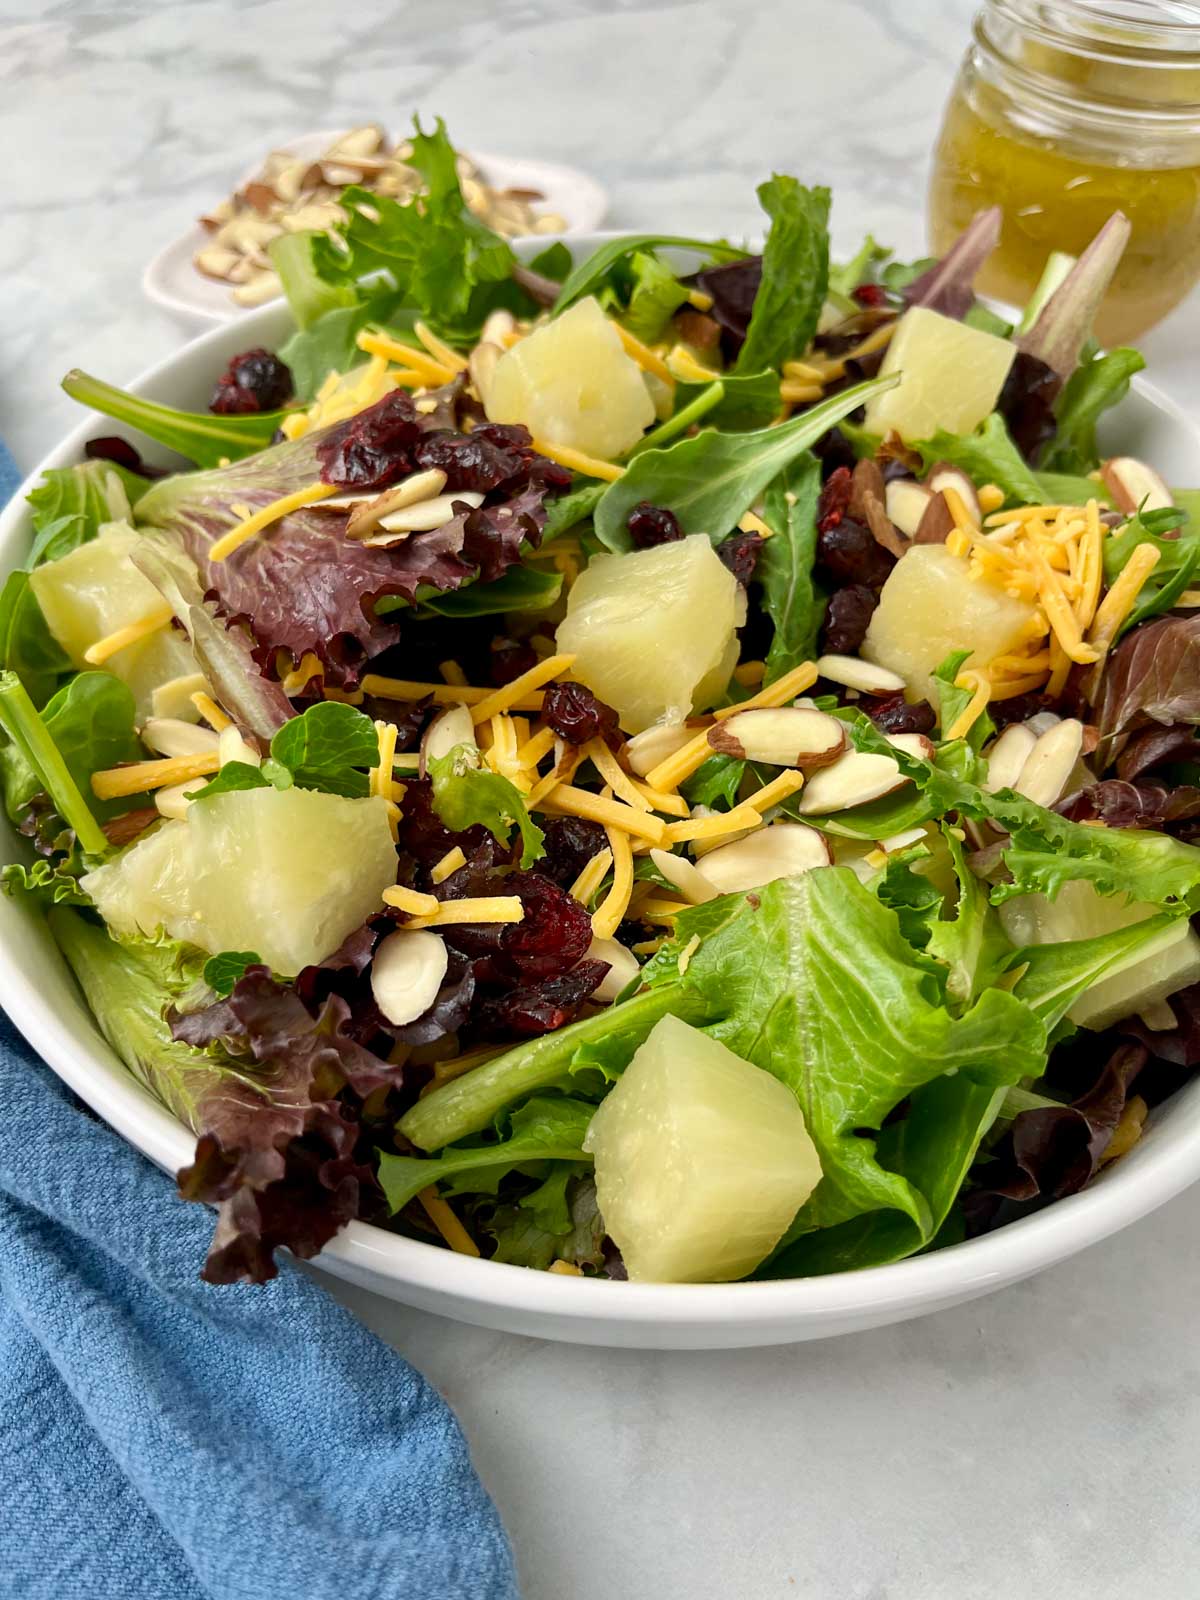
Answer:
850;715;1200;907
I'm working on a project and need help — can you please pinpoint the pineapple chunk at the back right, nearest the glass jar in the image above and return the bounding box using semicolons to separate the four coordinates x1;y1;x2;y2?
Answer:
866;306;1016;438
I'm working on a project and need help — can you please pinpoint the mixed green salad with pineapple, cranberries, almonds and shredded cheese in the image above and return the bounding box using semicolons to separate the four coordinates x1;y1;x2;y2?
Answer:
0;125;1200;1294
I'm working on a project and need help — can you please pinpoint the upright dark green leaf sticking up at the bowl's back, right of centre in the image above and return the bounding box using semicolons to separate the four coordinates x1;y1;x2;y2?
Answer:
734;173;829;373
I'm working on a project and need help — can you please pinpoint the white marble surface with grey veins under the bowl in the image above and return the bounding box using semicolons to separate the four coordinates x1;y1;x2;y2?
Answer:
0;0;1200;1600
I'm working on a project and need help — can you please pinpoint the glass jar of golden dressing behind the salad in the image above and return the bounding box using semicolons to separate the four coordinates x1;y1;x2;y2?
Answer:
930;0;1200;344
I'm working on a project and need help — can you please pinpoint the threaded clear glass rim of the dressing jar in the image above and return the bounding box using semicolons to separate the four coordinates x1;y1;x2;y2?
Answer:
973;0;1200;123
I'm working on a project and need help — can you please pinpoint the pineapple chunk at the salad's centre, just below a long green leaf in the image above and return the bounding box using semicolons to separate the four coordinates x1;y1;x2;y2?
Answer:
557;533;744;733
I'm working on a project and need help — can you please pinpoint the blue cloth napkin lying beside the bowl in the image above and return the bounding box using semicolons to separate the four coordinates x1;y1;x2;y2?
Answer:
0;432;517;1600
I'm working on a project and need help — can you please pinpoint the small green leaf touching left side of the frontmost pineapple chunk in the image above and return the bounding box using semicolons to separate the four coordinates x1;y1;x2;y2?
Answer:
379;1094;595;1227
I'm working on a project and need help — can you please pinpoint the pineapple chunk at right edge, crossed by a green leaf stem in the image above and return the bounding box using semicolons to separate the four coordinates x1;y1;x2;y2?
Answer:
1000;880;1200;1029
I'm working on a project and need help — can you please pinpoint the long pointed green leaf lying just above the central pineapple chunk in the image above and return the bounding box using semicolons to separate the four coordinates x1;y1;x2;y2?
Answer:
595;376;899;550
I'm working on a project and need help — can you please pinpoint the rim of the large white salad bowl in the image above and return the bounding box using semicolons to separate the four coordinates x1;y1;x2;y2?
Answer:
9;249;1200;1342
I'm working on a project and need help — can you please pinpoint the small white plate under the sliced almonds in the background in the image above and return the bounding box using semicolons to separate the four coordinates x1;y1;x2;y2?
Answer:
142;128;608;325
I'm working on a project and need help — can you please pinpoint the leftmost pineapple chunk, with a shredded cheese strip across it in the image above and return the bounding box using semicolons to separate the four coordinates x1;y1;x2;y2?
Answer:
29;522;195;718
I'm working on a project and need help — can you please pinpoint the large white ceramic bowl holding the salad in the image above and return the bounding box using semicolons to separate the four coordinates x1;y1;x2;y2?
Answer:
9;235;1200;1349
